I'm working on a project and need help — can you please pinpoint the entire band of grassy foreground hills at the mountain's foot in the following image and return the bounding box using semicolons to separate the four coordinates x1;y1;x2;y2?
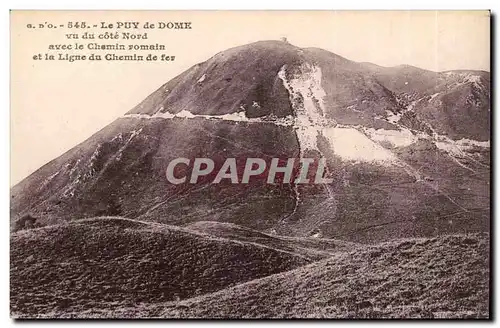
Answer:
11;218;489;318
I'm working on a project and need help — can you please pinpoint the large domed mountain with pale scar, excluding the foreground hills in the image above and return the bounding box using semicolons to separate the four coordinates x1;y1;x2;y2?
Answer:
11;41;490;243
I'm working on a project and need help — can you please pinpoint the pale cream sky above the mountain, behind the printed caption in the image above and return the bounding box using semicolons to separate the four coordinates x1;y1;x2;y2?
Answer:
10;11;490;186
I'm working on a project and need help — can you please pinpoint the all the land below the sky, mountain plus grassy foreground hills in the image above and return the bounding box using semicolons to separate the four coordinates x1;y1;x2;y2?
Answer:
10;41;491;318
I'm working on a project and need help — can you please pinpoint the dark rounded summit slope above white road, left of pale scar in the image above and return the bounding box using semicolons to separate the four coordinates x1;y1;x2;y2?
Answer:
129;41;303;117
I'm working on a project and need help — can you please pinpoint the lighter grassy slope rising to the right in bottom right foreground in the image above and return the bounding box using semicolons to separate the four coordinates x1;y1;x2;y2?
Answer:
78;234;489;318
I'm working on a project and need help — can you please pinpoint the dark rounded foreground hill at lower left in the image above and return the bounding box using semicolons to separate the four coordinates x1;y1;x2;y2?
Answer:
10;218;311;317
